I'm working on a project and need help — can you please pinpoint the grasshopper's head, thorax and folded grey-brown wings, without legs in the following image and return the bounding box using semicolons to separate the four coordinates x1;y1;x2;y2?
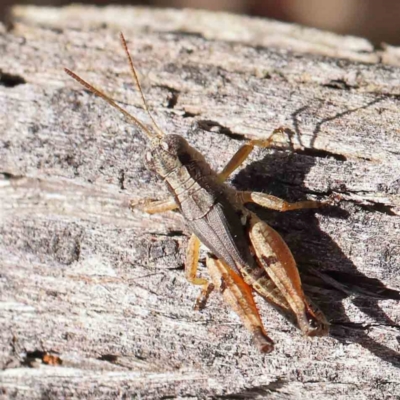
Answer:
146;135;256;271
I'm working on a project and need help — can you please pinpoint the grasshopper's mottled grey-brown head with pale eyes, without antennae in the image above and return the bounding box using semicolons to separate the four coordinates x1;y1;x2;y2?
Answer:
146;135;199;178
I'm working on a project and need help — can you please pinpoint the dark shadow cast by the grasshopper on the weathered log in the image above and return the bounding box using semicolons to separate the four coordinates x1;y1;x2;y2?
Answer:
232;101;400;367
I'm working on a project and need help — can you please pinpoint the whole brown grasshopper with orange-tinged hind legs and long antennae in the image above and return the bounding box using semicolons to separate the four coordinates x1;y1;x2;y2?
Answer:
65;34;329;353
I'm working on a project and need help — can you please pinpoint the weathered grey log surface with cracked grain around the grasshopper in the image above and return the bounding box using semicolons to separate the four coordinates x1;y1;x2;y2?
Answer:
0;7;400;399
